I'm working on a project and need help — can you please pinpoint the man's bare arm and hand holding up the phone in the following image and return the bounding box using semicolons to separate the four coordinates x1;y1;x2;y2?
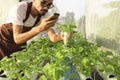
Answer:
13;17;57;44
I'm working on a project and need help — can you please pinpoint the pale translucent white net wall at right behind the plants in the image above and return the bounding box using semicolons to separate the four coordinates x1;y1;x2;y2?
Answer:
86;0;120;52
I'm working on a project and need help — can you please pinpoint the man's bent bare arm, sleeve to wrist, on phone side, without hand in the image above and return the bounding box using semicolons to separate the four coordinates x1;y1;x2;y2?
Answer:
13;25;42;44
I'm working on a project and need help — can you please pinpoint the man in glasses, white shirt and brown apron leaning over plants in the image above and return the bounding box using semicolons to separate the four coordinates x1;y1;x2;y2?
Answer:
0;0;71;59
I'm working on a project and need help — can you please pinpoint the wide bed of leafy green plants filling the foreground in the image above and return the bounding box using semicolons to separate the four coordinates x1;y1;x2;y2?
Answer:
0;23;120;80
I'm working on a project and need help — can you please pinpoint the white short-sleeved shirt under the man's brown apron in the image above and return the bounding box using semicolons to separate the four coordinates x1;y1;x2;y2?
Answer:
6;2;49;27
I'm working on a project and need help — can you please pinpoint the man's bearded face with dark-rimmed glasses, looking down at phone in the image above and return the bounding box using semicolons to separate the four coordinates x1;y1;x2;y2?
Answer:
35;0;53;15
